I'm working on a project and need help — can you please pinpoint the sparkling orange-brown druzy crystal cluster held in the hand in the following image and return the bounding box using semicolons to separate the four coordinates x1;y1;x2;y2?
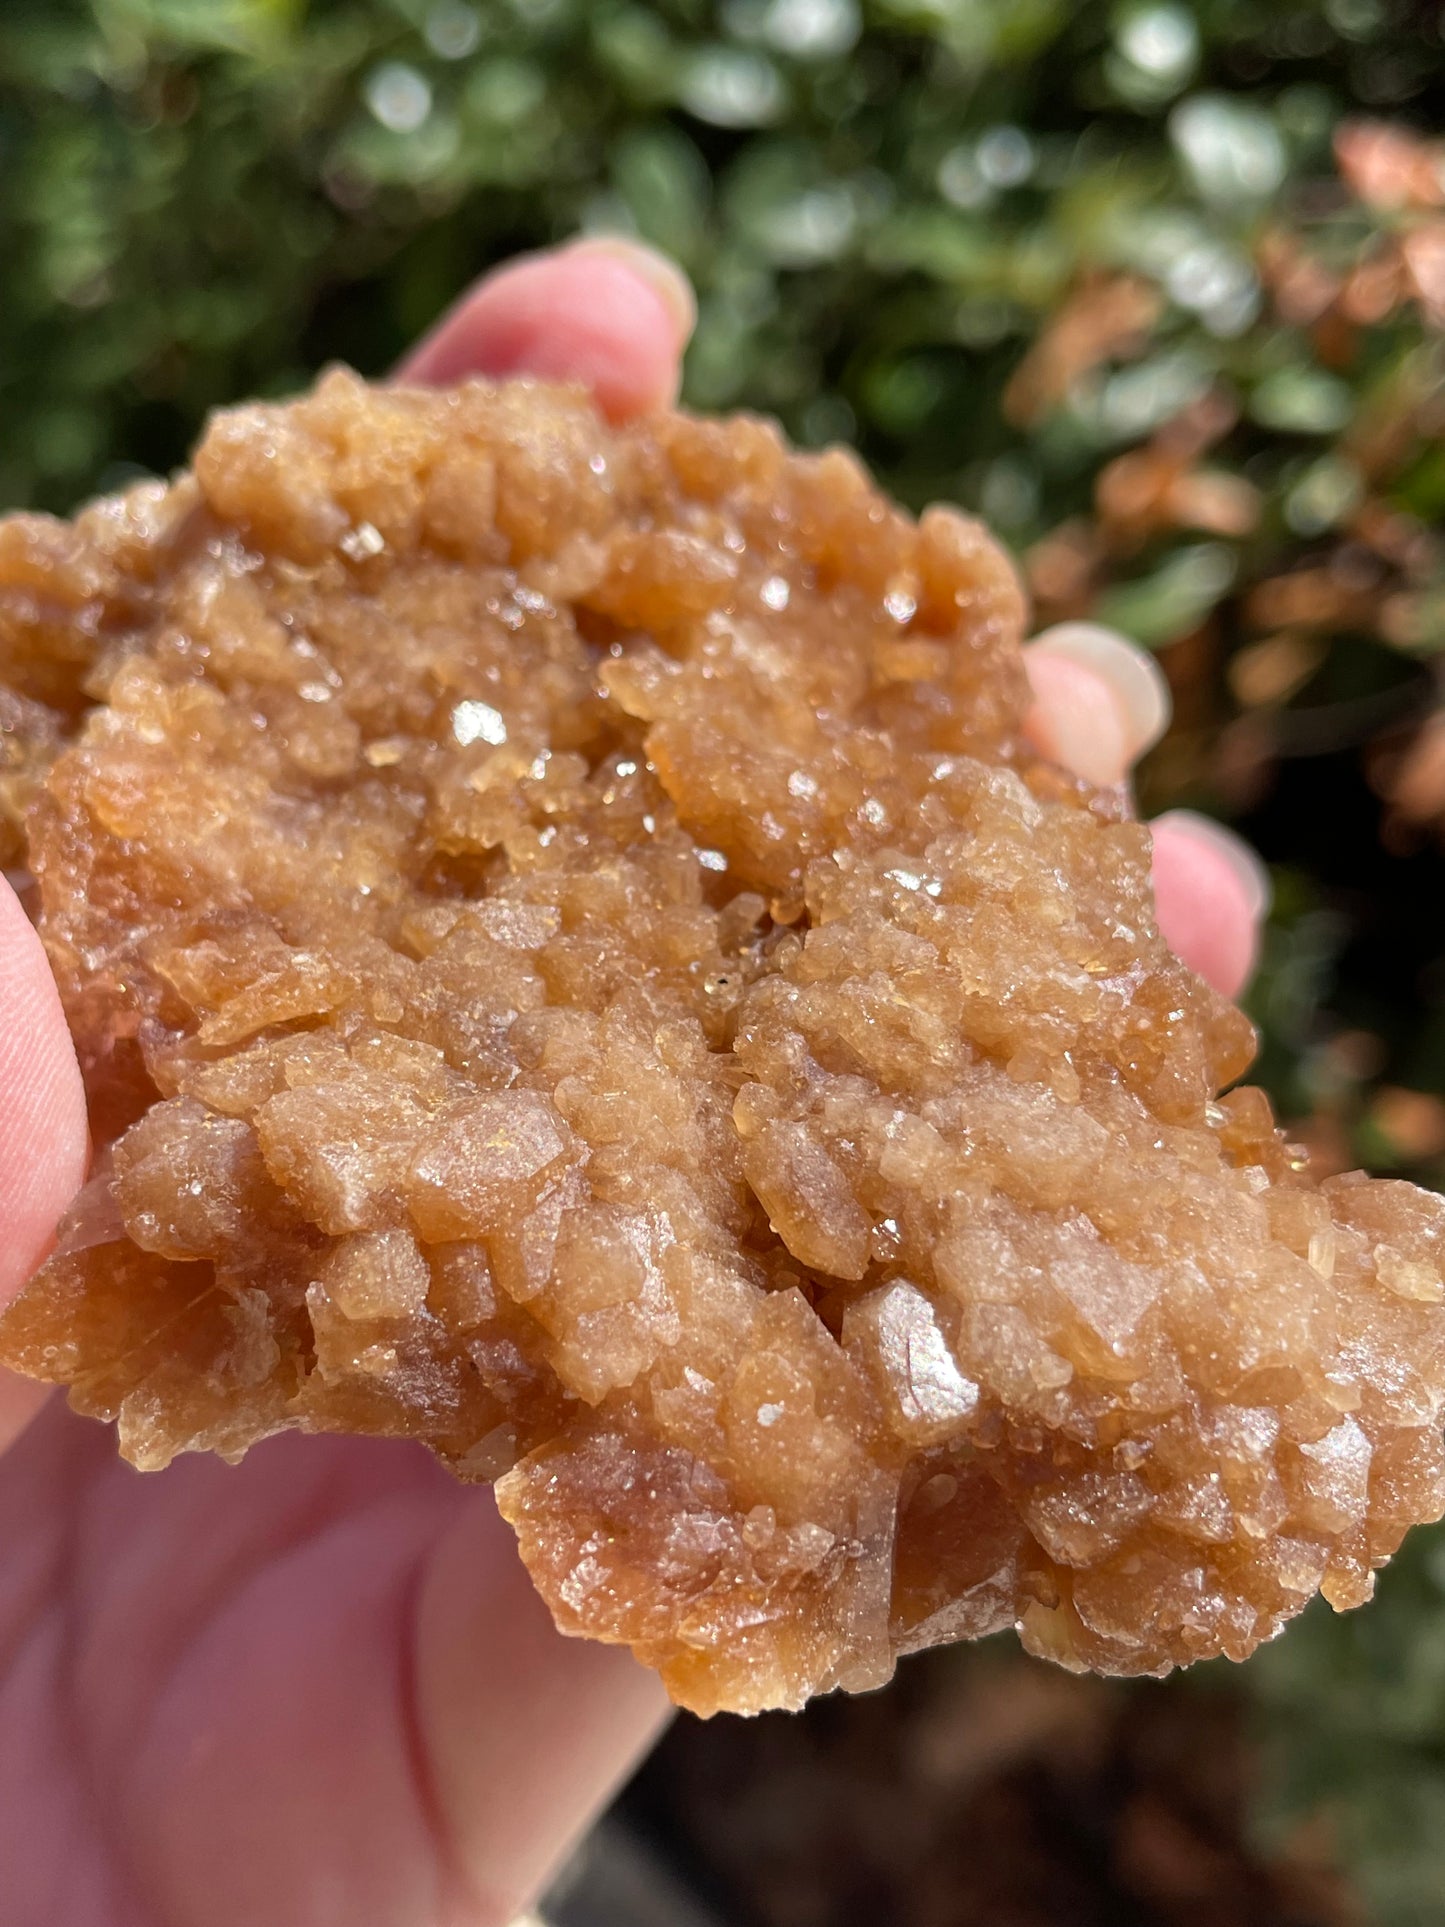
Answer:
0;374;1445;1711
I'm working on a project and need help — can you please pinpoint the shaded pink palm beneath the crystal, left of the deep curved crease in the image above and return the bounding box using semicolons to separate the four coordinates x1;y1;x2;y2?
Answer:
0;1401;539;1927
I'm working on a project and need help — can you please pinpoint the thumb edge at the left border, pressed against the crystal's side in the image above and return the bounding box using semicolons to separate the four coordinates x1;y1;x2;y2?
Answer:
0;881;89;1305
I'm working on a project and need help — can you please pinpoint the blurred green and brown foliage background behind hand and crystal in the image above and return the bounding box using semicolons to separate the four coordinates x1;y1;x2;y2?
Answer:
0;0;1445;1927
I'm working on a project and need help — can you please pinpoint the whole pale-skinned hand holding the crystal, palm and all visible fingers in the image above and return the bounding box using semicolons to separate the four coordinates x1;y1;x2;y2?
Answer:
0;243;1264;1927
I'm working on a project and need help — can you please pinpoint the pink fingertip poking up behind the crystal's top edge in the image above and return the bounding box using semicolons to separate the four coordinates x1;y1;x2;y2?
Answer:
401;237;694;420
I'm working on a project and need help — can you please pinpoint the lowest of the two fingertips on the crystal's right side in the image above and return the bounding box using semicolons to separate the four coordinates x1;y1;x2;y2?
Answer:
1150;809;1270;996
